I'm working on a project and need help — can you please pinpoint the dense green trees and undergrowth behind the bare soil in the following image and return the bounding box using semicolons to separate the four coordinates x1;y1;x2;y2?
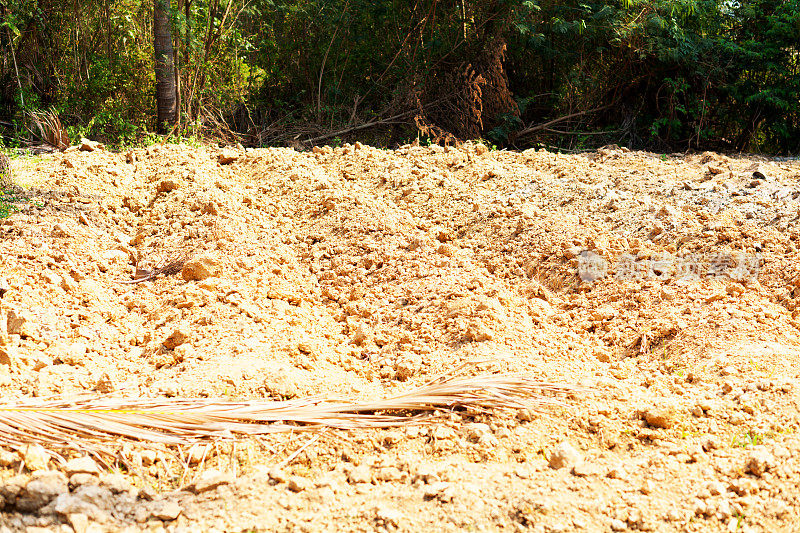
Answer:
0;0;800;155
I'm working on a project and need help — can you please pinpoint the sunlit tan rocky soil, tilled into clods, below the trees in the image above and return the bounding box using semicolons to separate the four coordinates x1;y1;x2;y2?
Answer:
0;143;800;533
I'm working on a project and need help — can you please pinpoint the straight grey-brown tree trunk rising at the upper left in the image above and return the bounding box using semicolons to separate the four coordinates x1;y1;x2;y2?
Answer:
153;0;178;133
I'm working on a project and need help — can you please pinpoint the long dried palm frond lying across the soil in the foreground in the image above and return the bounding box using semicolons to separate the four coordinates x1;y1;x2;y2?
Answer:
0;374;577;453
